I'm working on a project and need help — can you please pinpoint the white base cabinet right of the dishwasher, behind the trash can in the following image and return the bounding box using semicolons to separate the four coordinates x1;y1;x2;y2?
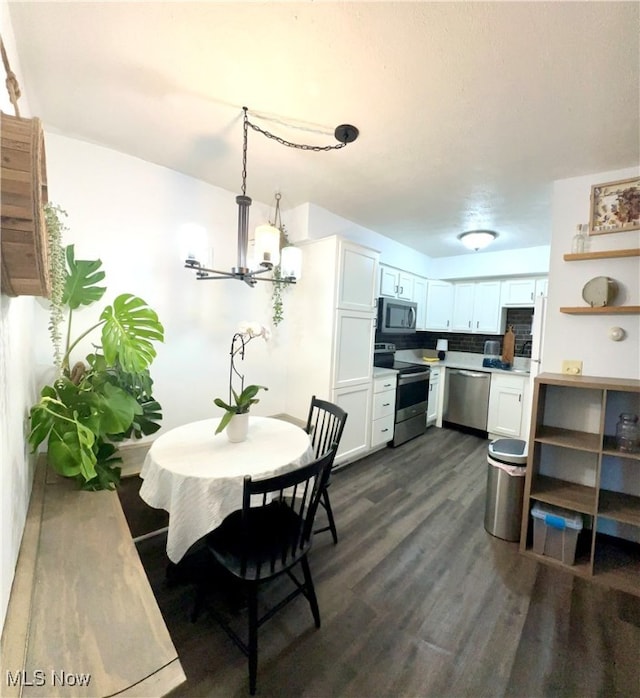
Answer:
487;373;528;439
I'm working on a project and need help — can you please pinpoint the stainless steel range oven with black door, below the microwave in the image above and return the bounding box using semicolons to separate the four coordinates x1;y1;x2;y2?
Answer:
373;343;431;447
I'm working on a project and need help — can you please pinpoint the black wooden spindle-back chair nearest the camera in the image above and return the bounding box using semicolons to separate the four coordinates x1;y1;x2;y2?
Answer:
191;444;337;695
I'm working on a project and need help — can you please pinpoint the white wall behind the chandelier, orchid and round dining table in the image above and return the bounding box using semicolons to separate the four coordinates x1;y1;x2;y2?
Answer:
38;133;296;433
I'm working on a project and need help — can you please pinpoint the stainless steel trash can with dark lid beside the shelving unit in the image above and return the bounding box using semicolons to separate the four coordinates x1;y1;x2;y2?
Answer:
484;439;527;541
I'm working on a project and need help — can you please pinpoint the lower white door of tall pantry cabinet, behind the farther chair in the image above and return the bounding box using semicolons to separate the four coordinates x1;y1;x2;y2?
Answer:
333;382;372;465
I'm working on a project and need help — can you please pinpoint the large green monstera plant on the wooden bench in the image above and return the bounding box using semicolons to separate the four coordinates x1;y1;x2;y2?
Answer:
28;230;164;490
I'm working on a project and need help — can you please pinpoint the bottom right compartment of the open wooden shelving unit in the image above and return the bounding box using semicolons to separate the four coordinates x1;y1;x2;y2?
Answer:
593;533;640;596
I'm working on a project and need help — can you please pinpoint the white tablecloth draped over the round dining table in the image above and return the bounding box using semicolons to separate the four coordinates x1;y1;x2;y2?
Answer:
140;416;313;562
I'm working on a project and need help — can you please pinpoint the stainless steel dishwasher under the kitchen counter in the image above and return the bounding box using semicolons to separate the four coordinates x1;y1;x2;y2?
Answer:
443;368;491;431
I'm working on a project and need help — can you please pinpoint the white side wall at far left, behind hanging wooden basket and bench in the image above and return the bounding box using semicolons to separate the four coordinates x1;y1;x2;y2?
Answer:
0;1;36;626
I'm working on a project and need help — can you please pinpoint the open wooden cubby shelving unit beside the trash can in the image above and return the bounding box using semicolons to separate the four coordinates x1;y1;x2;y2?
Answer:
520;373;640;596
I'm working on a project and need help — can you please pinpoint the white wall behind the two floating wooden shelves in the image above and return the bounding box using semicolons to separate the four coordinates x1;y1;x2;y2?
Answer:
542;167;640;378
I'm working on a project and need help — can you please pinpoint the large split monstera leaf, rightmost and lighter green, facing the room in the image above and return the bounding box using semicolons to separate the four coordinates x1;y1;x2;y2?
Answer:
100;293;164;373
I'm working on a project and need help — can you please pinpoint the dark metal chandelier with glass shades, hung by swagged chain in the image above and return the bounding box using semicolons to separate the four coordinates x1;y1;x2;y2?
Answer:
184;107;359;286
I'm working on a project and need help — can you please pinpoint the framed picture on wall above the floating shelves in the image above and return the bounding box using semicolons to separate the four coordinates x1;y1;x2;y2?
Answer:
589;177;640;235
